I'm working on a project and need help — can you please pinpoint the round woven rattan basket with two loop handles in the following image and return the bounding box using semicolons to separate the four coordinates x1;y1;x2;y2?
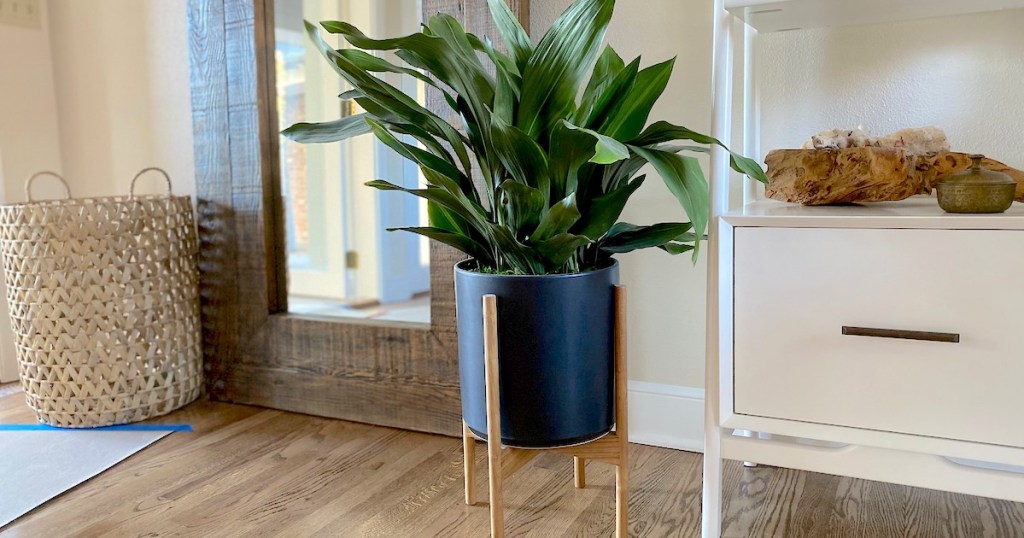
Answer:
0;168;202;427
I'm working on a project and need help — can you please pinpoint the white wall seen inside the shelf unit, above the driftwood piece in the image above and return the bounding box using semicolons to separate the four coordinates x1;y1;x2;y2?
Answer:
757;9;1024;168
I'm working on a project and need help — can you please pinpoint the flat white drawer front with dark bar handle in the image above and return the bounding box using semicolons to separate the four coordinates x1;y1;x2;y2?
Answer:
733;227;1024;447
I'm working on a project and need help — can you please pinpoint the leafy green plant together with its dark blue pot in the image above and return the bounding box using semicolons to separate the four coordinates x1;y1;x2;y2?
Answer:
284;0;767;448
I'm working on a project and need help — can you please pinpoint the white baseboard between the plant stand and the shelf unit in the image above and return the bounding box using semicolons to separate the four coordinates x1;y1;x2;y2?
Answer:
629;381;705;452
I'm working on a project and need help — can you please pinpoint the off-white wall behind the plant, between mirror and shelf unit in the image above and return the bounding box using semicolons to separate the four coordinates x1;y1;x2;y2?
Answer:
530;0;713;386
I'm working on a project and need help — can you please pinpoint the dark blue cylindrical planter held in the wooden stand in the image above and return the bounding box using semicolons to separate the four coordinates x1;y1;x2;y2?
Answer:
455;260;618;448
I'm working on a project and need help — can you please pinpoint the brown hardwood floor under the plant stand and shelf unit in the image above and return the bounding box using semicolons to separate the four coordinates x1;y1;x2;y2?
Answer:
0;392;1024;538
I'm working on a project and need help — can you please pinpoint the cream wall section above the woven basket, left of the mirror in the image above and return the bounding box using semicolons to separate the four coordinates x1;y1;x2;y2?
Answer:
49;0;196;196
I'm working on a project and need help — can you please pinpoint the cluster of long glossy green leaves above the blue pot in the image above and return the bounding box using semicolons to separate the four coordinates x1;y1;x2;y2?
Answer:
284;0;767;275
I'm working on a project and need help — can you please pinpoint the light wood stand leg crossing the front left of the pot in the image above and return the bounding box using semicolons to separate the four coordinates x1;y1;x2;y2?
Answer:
483;295;505;538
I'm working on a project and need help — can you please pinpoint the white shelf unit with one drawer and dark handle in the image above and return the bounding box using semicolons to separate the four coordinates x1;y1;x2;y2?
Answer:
702;0;1024;538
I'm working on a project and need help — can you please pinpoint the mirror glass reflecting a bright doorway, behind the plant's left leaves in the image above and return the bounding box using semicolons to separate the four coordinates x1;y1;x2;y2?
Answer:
274;0;430;323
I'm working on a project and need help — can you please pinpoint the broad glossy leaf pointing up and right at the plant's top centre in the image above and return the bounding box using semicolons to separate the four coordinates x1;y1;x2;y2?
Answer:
516;0;614;139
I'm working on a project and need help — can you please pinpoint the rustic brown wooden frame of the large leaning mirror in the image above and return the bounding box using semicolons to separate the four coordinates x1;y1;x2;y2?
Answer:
188;0;529;436
